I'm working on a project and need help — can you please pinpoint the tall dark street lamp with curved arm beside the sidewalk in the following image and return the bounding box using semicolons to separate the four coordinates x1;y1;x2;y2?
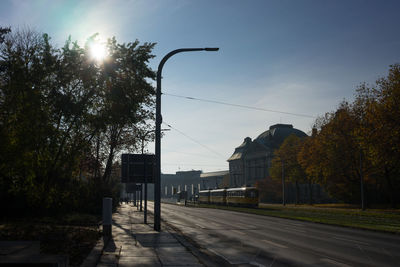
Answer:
154;47;219;231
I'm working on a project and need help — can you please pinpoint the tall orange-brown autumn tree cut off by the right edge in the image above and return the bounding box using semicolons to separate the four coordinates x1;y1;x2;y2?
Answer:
356;64;400;207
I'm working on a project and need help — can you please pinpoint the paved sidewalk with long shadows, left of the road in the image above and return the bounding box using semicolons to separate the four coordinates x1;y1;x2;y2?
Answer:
97;204;203;267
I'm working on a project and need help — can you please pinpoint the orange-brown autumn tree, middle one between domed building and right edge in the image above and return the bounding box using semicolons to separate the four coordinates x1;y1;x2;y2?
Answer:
309;101;361;202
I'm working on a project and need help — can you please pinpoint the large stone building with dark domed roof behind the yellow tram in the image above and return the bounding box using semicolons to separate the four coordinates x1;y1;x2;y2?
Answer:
228;124;307;187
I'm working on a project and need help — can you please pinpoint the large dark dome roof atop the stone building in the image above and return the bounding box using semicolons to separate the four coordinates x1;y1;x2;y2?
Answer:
254;124;307;148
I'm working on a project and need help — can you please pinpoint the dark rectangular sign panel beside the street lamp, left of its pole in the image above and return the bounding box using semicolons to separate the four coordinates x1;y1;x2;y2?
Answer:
121;154;155;183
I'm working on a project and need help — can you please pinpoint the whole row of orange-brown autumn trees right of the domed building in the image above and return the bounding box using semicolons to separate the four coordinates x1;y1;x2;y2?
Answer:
270;64;400;207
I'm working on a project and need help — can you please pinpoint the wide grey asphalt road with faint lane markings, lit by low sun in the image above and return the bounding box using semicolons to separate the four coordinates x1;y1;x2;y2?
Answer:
149;203;400;266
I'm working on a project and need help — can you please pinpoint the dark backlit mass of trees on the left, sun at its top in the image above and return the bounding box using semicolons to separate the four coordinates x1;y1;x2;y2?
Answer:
0;28;155;216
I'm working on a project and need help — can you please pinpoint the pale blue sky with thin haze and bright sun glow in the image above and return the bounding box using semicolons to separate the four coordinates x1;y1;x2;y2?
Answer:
0;0;400;173
